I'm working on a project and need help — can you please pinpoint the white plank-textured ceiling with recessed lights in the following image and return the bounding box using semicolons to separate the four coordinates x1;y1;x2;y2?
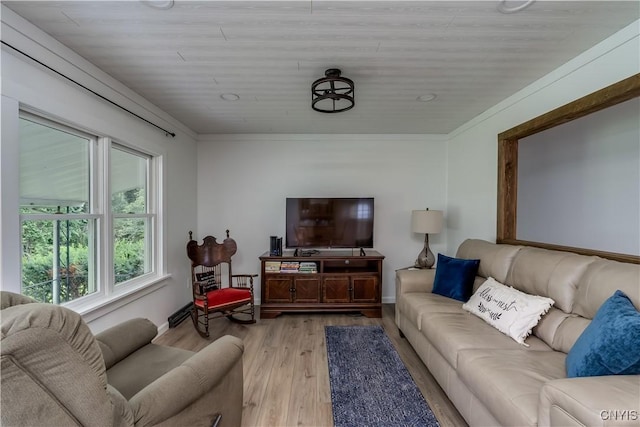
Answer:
3;0;640;134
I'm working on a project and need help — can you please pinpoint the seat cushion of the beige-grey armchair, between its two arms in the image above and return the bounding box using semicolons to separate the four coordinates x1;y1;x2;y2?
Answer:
107;344;194;400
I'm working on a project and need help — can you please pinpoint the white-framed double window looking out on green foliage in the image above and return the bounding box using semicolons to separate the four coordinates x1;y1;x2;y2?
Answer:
19;113;161;306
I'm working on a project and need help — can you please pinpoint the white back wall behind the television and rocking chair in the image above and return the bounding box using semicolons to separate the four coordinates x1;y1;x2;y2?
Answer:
197;135;446;302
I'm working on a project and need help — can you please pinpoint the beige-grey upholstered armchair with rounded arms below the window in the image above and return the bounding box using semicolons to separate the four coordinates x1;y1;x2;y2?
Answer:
0;292;244;427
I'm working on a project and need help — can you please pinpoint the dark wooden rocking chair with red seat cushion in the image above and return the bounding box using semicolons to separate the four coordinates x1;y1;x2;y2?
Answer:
187;230;258;337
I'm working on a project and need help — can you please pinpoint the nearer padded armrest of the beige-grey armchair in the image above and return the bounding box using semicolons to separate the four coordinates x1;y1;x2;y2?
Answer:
129;335;244;426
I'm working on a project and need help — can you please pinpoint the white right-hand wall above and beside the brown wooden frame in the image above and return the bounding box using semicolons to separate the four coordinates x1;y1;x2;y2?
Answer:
446;21;640;254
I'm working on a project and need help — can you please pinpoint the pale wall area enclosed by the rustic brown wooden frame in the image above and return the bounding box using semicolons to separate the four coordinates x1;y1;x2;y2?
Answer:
516;98;640;255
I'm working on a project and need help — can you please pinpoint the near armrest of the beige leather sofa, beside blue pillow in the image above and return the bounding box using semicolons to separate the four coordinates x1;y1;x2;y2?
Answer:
538;375;640;426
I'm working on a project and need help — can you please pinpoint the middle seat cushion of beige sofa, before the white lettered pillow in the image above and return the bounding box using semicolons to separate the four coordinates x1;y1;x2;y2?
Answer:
421;306;551;369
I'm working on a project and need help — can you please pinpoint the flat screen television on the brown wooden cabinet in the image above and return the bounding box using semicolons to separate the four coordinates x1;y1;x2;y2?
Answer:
285;197;373;248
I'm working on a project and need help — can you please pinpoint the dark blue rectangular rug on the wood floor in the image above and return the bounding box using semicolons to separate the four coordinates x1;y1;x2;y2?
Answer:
325;326;439;427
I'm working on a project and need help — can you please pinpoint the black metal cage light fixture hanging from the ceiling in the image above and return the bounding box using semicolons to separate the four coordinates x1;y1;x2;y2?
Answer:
311;68;355;113
